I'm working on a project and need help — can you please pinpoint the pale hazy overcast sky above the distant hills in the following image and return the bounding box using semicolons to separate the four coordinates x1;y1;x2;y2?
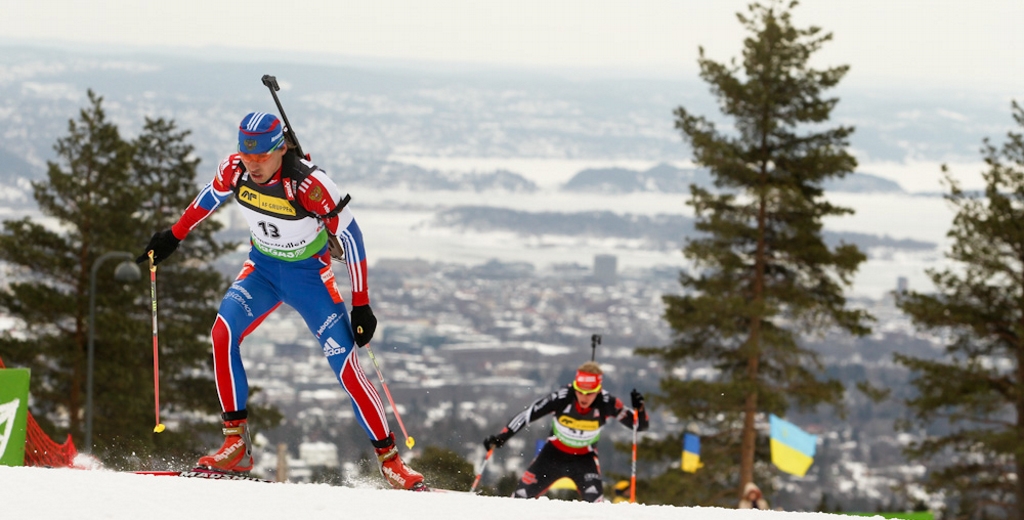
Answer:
0;0;1024;95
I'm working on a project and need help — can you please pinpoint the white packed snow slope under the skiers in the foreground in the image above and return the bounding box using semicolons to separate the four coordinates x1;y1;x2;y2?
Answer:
0;466;881;520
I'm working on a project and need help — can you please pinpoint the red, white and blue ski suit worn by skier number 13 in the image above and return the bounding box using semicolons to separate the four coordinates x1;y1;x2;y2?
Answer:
171;153;390;441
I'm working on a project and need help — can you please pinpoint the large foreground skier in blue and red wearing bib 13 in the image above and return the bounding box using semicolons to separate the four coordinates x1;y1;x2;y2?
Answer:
138;112;425;489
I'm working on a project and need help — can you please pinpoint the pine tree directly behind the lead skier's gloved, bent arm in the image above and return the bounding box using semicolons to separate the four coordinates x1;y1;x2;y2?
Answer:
121;118;243;461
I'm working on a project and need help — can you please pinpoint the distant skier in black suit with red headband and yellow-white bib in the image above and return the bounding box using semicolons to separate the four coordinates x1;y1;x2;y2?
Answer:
483;361;648;502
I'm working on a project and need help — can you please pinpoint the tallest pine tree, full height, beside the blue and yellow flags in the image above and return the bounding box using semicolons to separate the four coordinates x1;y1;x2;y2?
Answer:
639;1;869;506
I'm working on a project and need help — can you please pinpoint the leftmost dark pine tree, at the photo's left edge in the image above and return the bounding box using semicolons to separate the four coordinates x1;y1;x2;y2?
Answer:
0;91;134;441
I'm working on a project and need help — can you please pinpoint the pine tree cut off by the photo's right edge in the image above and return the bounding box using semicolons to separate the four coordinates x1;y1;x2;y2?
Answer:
895;102;1024;520
